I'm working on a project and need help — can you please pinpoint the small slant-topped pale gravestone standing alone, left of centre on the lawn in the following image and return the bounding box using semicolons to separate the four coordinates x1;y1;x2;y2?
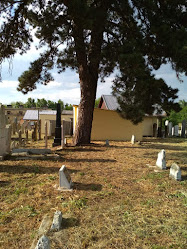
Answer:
59;165;72;190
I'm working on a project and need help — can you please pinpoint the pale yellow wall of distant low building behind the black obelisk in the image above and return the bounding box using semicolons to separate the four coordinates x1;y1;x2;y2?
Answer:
40;114;73;134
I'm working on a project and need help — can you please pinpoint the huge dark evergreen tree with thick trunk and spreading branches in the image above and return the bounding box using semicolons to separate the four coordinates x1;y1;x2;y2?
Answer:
0;0;187;144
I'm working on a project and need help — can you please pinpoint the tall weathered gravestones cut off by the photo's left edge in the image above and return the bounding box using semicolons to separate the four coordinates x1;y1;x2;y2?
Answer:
0;105;11;157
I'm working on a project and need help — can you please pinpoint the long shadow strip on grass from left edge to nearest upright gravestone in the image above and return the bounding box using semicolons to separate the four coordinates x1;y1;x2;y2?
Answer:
0;165;59;174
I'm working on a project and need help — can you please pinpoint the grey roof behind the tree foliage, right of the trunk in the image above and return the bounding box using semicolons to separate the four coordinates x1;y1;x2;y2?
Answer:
98;95;166;116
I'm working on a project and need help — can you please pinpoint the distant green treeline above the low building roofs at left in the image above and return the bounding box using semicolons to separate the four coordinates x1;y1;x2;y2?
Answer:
5;98;73;110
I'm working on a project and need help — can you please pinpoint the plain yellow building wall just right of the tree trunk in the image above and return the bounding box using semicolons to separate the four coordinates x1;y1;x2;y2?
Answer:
91;108;143;141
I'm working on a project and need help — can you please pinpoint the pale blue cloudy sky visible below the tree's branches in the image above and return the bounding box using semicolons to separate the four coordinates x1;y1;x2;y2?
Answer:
0;41;187;104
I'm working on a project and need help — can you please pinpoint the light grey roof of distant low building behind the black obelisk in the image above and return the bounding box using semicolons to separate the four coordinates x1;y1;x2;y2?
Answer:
23;110;73;120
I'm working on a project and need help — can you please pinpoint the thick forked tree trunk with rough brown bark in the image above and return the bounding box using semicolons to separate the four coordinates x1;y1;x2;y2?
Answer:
73;3;106;145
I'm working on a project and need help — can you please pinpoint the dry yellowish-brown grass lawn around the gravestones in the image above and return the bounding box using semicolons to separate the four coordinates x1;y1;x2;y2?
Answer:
0;138;187;249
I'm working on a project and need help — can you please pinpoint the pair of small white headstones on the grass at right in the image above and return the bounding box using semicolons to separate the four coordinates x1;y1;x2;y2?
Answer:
156;150;182;181
